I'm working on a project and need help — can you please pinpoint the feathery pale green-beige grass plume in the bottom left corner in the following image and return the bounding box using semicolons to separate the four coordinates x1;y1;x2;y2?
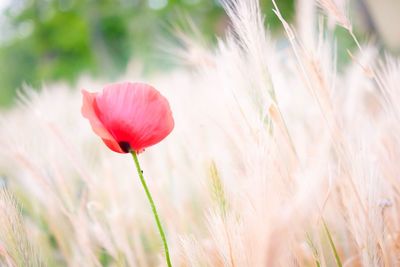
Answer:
0;187;43;267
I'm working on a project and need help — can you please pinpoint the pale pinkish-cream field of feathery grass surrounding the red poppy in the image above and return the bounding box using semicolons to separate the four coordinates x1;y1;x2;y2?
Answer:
0;0;400;267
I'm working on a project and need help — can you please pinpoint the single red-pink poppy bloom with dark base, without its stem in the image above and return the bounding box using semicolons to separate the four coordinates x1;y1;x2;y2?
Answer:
82;82;174;153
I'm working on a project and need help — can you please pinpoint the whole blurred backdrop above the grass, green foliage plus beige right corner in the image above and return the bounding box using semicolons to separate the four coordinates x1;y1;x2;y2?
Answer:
0;0;400;109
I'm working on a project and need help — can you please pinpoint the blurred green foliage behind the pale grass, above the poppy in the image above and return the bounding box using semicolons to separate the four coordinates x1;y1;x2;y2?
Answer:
0;0;293;105
